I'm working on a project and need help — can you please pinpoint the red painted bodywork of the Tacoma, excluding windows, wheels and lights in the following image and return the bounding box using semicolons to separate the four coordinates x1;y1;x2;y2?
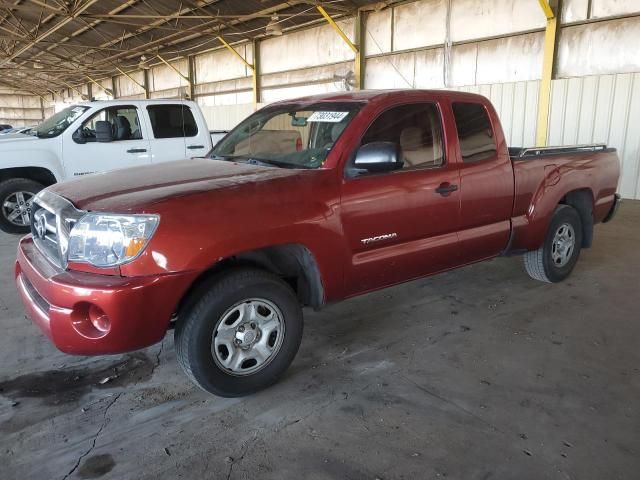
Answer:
16;90;619;354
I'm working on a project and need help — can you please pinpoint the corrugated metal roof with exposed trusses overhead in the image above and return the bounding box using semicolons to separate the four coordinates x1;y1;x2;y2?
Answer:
0;0;383;94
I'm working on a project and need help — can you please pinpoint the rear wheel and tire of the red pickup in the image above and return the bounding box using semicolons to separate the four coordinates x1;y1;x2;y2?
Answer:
524;205;582;283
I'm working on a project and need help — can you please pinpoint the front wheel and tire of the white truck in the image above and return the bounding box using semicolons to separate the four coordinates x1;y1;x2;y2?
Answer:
0;178;44;233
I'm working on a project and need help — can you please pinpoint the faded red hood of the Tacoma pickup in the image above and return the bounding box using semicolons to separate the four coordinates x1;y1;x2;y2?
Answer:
49;159;300;213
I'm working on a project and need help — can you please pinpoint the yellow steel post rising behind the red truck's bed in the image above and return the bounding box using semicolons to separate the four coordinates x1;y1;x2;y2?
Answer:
536;0;558;147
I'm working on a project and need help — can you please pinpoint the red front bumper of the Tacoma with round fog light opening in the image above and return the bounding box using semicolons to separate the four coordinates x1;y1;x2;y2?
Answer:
15;236;196;355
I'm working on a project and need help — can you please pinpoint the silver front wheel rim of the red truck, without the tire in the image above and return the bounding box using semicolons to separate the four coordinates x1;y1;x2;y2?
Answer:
211;298;284;375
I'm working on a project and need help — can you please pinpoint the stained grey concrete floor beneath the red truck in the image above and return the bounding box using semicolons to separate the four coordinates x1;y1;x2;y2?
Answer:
0;202;640;480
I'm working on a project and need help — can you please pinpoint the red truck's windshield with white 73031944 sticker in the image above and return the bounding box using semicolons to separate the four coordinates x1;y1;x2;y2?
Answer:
210;102;362;168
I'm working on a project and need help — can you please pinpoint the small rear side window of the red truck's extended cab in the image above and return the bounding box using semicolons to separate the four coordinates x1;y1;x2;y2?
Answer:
453;102;498;163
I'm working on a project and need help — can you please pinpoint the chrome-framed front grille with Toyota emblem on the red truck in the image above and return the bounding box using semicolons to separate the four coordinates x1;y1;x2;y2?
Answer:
31;190;85;268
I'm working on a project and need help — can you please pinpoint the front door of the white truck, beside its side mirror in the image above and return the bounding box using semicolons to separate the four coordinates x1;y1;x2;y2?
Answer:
62;105;151;178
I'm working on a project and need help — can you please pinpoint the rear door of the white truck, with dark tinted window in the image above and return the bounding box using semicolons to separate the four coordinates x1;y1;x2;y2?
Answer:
147;103;211;163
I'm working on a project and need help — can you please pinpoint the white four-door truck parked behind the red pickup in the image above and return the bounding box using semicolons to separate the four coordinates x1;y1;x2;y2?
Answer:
0;100;213;233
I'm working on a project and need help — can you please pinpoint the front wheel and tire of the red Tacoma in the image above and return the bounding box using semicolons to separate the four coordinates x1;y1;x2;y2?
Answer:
175;268;303;397
